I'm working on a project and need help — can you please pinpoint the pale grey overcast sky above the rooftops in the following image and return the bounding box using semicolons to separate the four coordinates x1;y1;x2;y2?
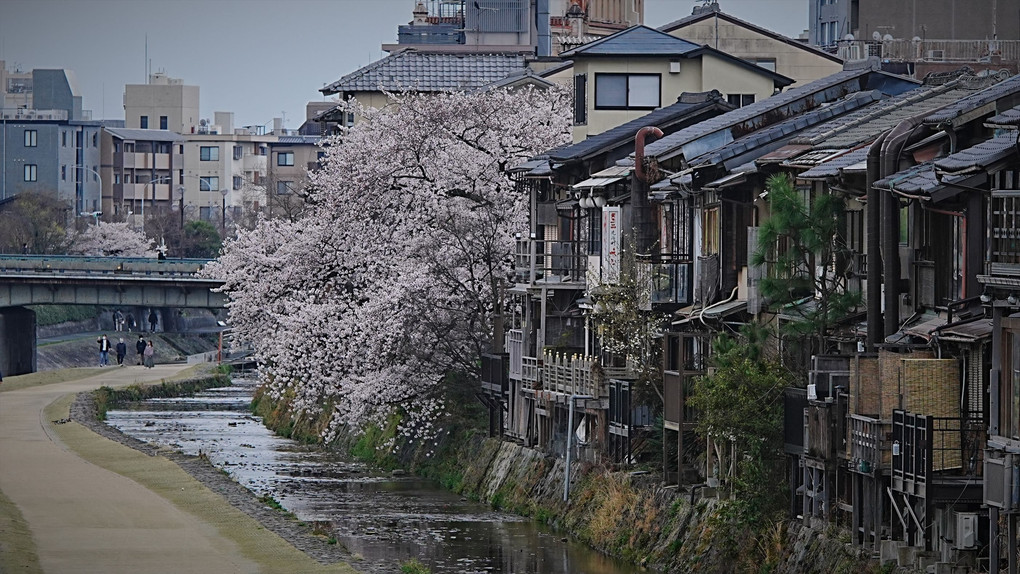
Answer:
0;0;808;128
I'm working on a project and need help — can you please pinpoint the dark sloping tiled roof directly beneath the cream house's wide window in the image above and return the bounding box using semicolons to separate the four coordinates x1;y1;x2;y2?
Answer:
548;92;729;162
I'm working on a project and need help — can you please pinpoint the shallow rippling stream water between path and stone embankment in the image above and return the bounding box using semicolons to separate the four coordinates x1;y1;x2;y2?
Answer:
107;380;641;574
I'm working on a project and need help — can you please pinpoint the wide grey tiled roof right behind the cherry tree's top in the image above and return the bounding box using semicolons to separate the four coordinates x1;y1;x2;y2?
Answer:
319;49;524;96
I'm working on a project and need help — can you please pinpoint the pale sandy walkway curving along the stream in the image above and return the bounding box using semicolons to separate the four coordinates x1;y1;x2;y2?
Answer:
0;365;350;574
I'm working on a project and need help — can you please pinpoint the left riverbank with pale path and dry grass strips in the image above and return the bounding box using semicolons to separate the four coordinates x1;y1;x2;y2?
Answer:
0;365;363;574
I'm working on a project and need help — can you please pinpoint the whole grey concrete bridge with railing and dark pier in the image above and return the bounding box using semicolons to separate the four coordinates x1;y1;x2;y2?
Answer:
0;255;226;374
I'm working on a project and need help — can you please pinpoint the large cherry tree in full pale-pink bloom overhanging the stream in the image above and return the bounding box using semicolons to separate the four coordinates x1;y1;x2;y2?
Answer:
207;88;569;438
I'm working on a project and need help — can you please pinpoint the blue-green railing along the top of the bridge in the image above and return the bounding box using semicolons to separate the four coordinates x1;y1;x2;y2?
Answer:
0;255;209;275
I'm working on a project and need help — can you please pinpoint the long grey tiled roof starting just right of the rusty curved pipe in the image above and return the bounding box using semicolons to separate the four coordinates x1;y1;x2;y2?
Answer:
645;68;901;159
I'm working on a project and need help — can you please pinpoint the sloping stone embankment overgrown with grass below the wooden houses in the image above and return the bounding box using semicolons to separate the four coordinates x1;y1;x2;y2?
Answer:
254;389;881;574
